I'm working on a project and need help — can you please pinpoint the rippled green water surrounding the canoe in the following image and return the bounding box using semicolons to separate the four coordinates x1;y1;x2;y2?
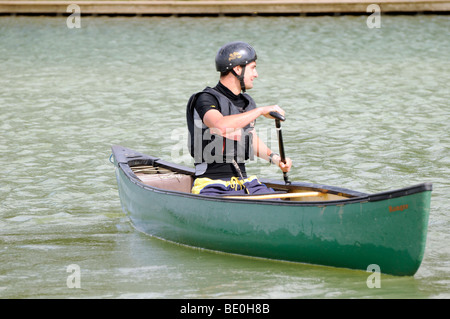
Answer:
0;15;450;298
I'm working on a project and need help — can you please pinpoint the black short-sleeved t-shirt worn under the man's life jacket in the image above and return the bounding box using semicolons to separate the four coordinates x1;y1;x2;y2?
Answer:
194;82;253;180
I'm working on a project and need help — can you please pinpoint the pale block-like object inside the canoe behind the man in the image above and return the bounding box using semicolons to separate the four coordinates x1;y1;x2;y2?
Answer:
135;173;193;193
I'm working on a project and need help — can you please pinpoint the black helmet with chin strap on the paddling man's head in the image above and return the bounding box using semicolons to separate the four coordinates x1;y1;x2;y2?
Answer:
216;41;256;73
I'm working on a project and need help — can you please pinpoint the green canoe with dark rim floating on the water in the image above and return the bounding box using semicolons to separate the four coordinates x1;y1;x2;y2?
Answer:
112;146;432;276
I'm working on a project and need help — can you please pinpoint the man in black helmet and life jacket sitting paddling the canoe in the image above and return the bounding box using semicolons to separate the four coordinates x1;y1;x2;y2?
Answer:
186;42;292;195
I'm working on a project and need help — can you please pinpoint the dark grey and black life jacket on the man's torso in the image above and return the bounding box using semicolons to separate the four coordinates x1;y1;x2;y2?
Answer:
186;87;256;164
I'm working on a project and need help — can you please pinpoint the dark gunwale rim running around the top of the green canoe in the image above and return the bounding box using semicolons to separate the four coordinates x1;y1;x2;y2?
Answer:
112;145;433;206
